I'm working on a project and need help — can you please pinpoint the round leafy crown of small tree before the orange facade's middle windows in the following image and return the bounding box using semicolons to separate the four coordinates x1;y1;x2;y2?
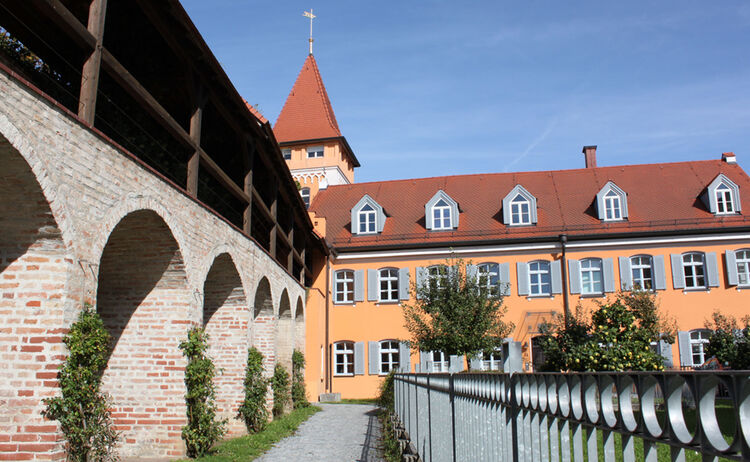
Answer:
403;258;513;362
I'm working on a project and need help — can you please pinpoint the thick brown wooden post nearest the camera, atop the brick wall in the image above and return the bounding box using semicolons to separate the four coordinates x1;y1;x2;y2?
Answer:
78;0;107;125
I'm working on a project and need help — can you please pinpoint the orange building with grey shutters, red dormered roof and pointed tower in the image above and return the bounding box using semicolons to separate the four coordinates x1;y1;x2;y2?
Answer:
274;56;750;398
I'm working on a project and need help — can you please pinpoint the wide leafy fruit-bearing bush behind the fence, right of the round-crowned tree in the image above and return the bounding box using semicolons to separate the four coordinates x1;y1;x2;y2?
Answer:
540;291;675;371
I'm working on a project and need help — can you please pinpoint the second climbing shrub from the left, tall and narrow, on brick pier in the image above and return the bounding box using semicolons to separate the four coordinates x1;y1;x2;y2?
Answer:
180;327;226;457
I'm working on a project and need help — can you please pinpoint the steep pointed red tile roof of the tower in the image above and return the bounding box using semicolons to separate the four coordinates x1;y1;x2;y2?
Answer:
273;55;341;143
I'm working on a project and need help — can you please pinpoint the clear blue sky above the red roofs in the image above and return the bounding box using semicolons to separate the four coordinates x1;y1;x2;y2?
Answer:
182;0;750;182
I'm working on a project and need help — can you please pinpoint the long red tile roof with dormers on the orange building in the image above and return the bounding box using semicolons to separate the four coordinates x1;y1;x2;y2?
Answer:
310;160;750;250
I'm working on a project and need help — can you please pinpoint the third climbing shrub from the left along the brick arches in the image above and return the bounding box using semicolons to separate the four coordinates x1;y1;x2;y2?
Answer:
238;347;268;433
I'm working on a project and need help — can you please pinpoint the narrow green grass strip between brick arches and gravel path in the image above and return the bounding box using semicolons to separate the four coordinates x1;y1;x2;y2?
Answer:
179;406;321;462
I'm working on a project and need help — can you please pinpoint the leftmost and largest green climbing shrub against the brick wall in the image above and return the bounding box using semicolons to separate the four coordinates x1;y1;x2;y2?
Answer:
42;305;118;462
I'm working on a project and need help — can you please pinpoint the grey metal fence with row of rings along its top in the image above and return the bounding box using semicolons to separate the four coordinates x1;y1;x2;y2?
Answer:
394;371;750;462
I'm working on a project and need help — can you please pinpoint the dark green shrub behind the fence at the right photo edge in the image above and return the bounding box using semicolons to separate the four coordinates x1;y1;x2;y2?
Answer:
706;310;750;370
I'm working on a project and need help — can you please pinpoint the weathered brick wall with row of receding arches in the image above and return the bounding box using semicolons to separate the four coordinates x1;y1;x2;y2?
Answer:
0;67;305;460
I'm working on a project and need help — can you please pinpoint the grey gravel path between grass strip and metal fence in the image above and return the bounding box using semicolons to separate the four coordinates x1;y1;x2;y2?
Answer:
255;403;383;462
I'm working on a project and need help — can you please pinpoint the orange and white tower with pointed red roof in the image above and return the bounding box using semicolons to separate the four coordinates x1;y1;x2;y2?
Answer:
273;53;359;205
